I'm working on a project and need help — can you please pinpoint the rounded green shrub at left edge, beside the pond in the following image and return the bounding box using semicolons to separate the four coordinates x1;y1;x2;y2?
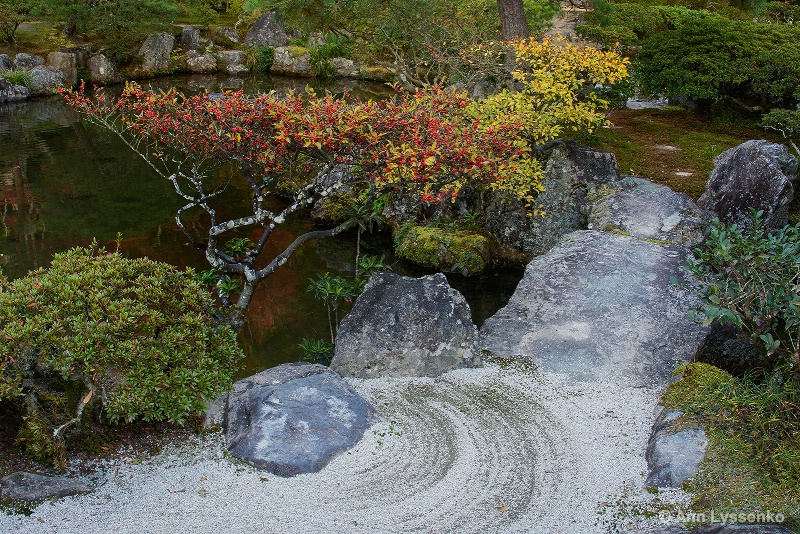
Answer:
0;248;242;466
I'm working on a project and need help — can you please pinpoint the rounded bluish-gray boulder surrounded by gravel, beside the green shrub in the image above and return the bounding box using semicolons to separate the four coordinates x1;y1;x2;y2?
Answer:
225;364;377;476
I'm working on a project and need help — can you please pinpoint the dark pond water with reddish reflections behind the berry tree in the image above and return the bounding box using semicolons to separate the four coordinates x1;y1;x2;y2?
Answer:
0;76;522;376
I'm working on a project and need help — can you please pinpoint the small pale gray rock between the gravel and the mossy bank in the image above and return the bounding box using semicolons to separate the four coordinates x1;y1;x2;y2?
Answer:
645;410;708;488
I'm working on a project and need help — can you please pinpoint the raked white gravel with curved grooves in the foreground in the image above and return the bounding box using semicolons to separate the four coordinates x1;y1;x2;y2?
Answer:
0;365;687;534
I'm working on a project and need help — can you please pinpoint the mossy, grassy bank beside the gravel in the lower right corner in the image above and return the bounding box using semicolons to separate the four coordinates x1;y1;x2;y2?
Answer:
662;363;800;530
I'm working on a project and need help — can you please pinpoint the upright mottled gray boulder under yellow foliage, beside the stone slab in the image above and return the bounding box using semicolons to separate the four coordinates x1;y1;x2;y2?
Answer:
485;142;621;255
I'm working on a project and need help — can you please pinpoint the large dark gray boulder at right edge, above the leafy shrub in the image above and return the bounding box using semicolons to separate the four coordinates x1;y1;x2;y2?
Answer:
697;140;797;229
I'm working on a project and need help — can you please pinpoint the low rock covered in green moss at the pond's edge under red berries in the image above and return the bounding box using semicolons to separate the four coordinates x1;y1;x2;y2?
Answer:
395;226;490;274
